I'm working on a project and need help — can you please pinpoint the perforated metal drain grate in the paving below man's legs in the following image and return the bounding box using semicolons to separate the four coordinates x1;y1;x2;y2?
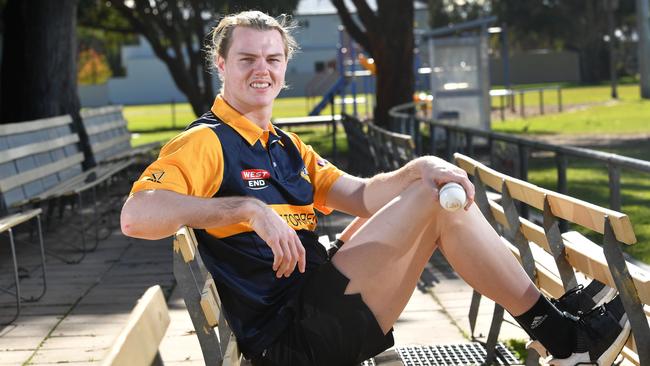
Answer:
361;342;521;366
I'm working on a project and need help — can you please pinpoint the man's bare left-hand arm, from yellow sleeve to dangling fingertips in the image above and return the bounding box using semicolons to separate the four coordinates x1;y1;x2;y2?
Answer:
120;190;306;277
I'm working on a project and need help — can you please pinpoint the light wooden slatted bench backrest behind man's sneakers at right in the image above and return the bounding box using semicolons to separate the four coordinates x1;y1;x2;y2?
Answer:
454;153;650;365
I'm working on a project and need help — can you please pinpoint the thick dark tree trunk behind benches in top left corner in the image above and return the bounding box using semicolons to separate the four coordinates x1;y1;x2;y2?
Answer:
0;0;79;123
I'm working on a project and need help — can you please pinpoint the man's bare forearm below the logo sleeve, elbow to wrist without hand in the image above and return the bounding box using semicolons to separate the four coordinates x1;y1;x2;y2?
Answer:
120;190;264;239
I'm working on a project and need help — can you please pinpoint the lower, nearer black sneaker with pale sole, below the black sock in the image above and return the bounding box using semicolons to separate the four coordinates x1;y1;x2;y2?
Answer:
547;296;630;366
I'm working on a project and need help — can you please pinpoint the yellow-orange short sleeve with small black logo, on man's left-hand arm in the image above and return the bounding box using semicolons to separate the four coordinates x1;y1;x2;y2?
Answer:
131;126;224;197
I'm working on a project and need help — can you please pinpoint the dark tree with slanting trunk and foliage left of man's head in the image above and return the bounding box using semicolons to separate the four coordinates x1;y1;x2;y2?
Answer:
80;0;298;115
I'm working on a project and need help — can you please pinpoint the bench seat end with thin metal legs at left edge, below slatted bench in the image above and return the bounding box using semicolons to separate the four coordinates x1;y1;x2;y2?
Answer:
0;208;47;325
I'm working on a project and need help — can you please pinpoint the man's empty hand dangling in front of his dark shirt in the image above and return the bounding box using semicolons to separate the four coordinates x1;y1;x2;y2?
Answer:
249;204;306;278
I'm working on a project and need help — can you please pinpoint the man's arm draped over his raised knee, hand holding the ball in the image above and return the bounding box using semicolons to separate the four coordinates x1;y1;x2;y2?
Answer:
326;156;474;217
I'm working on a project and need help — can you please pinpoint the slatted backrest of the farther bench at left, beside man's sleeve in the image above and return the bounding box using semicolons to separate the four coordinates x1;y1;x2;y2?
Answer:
81;106;131;164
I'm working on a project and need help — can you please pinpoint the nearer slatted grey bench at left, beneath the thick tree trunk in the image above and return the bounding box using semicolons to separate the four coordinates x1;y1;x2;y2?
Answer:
0;115;130;262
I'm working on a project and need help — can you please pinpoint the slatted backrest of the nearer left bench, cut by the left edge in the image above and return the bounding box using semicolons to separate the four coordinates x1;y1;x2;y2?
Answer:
0;115;84;213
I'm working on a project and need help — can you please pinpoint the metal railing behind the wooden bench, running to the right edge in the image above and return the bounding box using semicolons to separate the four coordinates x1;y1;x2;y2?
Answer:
389;103;650;216
